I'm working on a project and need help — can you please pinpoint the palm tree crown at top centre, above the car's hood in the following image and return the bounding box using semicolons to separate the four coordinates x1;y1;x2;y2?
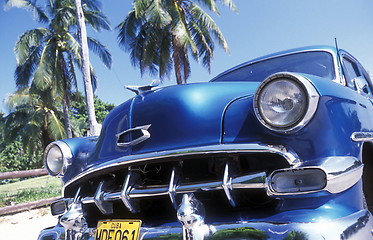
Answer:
117;0;236;84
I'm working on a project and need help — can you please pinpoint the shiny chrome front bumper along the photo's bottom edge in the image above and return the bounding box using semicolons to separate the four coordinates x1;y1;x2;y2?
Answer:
38;210;373;240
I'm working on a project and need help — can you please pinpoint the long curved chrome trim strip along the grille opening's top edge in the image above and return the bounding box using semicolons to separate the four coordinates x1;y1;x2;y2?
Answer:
62;144;300;193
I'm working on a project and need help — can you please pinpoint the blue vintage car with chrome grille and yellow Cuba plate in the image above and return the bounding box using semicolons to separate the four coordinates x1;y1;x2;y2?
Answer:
39;46;373;240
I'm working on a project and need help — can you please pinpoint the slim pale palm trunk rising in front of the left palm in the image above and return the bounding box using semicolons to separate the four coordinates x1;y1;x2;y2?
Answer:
75;0;100;136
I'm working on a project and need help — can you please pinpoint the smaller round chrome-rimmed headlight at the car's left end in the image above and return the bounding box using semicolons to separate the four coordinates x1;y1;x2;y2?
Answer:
43;141;73;177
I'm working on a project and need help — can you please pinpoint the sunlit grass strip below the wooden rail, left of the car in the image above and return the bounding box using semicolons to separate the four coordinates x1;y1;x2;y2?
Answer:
0;176;61;207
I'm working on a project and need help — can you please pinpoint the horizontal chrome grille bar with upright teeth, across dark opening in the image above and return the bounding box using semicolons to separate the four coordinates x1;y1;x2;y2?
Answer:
82;166;266;214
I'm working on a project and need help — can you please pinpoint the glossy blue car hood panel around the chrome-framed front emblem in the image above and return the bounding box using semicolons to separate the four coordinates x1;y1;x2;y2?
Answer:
89;82;259;164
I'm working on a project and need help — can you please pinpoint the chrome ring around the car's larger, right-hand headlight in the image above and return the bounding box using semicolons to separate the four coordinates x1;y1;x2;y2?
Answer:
254;72;320;133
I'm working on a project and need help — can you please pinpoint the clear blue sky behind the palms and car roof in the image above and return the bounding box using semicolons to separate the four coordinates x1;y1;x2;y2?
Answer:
0;0;373;112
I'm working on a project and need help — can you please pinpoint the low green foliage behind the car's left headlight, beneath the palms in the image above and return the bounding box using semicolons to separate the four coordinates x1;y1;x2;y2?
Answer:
0;91;115;172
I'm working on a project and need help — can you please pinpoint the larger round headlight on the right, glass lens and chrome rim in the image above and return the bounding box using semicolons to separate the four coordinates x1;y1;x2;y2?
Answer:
254;73;318;132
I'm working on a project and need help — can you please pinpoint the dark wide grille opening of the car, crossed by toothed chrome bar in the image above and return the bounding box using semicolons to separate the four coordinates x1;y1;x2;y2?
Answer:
64;153;289;227
